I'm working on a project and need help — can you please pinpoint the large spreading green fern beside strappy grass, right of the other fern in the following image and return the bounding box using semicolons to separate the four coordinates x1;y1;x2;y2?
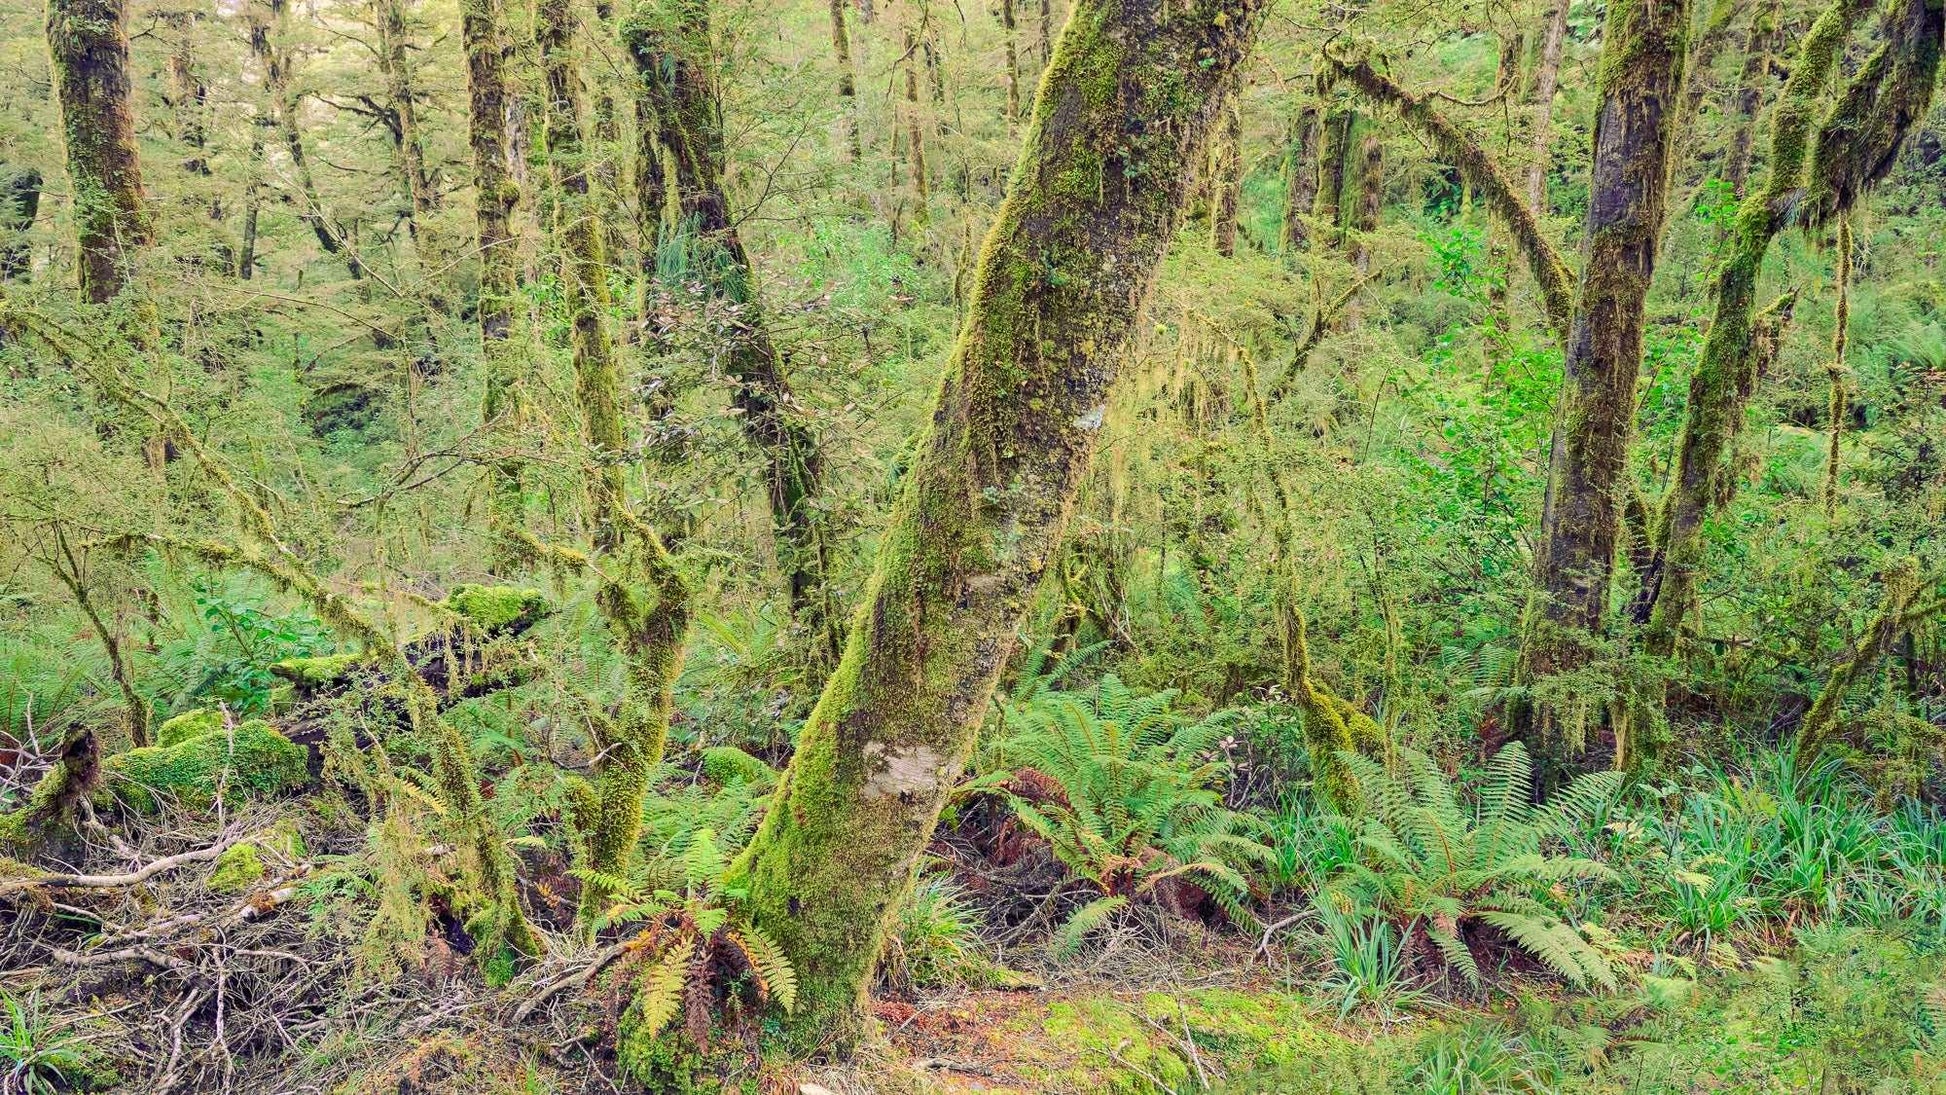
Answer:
1325;743;1619;988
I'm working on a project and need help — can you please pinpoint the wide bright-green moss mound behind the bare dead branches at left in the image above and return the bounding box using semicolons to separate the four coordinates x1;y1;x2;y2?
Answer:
97;720;309;813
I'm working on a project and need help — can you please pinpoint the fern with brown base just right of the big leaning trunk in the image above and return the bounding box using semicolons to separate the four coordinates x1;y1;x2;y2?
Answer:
1000;677;1271;934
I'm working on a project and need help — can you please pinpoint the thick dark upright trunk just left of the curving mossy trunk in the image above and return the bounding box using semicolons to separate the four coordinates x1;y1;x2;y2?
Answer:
1526;0;1689;782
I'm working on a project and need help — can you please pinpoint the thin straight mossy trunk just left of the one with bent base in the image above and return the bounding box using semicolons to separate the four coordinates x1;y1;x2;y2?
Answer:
459;0;523;568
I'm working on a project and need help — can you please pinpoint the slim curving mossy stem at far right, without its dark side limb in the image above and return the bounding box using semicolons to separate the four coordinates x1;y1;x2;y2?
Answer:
1639;0;1907;655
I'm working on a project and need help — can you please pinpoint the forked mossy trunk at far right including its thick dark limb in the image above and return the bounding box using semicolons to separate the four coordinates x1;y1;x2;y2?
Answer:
1637;0;1946;655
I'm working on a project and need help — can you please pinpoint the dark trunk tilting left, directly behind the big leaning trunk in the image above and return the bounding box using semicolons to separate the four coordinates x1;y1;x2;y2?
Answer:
623;0;841;663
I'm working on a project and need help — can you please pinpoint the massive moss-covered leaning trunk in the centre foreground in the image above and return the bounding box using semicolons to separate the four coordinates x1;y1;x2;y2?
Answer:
734;0;1265;1031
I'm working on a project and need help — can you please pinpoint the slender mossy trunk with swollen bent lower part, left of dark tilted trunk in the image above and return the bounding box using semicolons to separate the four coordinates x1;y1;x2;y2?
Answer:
535;0;691;920
